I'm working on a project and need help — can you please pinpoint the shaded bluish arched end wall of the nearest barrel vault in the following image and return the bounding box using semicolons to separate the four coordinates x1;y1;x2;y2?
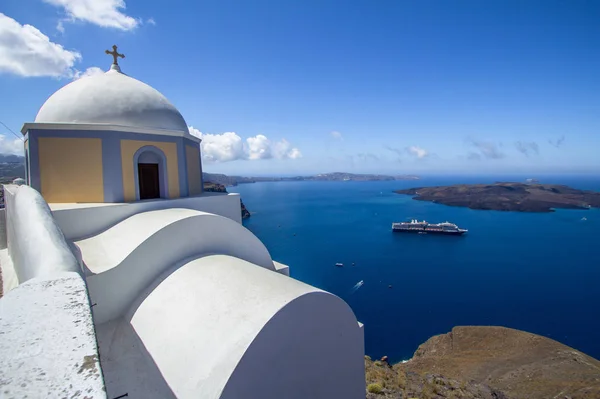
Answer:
220;292;365;399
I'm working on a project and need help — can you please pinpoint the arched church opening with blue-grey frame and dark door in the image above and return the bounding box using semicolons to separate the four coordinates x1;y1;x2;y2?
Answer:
133;146;169;200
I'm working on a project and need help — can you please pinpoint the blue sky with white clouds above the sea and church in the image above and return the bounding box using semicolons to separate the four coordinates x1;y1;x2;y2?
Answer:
0;0;600;175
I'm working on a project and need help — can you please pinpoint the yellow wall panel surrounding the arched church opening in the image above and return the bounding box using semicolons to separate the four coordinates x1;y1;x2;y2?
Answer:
121;140;179;201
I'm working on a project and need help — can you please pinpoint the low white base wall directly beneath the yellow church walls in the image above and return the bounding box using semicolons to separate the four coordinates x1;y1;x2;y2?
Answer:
50;193;242;241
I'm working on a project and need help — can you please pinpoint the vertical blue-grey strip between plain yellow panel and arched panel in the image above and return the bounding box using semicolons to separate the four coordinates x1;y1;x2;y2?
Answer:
102;136;125;202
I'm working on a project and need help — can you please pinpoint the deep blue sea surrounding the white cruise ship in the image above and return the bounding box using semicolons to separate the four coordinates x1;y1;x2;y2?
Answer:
228;176;600;361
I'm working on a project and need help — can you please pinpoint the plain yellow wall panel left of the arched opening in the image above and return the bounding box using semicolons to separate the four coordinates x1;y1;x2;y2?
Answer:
38;137;104;203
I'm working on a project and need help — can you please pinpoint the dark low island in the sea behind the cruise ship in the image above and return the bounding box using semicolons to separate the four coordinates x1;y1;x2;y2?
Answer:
394;183;600;212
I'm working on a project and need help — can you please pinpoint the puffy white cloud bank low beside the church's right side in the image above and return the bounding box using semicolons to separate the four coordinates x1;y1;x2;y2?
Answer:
189;126;302;163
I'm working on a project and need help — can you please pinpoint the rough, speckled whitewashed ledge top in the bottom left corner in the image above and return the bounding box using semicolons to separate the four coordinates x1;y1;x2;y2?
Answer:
0;272;106;399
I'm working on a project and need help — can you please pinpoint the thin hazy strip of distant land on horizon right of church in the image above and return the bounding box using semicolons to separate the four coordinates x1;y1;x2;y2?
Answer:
202;172;419;186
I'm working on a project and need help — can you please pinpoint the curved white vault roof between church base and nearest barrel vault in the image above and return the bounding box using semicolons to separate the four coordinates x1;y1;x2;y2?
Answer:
75;209;275;324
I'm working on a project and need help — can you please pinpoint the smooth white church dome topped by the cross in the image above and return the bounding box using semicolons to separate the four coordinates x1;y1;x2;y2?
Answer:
35;65;188;134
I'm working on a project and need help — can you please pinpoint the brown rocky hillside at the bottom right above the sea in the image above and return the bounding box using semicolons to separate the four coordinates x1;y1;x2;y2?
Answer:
365;327;600;399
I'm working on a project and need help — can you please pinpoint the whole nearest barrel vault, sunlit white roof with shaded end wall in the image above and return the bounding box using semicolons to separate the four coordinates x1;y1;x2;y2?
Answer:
98;255;365;399
